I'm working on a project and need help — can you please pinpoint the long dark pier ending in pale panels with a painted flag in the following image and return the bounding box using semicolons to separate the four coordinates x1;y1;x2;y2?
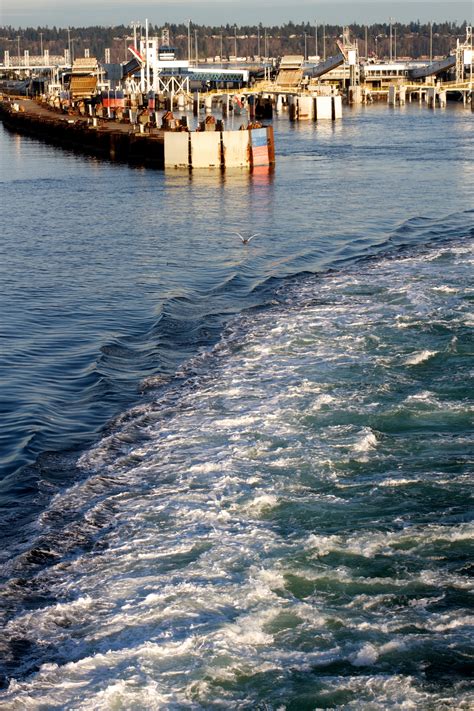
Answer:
0;99;275;170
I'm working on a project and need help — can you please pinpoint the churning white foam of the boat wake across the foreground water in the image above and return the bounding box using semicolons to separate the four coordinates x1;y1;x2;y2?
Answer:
2;235;472;711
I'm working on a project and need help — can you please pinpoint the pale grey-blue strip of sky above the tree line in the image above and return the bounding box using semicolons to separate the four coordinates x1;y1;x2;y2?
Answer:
0;0;474;28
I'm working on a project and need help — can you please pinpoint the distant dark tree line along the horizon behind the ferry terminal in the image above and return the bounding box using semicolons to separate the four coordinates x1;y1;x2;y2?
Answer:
0;21;466;62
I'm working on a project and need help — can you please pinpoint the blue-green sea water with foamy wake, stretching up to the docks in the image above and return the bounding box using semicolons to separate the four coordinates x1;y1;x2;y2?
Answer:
0;106;474;711
